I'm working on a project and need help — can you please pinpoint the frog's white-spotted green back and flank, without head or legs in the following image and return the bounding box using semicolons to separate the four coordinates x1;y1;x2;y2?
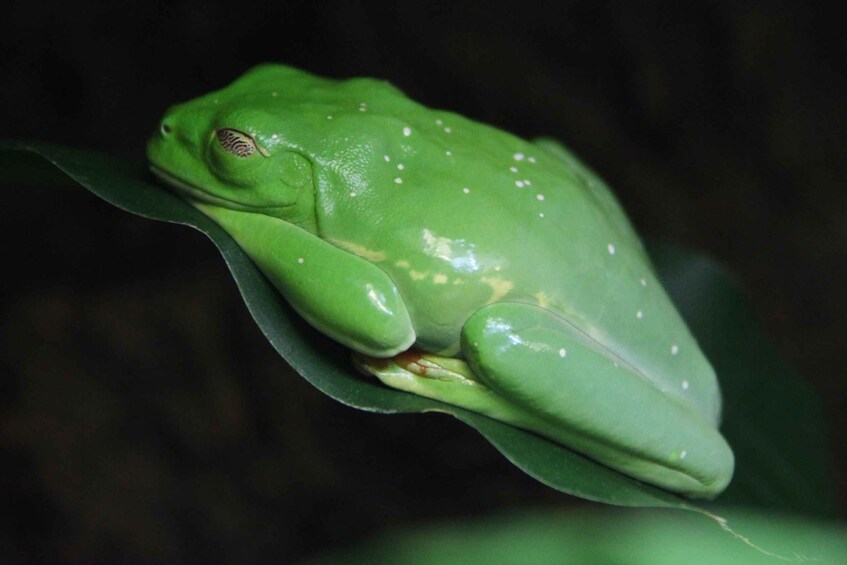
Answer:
243;68;720;420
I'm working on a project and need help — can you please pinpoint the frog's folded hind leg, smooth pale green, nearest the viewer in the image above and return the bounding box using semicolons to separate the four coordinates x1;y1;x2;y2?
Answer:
462;303;733;497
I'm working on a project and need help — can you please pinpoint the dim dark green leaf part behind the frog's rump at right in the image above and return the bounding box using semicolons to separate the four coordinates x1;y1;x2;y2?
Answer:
651;244;837;516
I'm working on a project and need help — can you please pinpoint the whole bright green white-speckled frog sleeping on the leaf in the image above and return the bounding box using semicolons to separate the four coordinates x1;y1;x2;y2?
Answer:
148;65;734;498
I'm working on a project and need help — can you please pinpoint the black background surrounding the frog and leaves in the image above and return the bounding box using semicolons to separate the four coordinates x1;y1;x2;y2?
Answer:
0;1;847;563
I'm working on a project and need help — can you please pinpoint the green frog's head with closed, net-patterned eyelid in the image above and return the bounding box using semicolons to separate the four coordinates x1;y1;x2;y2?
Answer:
147;67;314;229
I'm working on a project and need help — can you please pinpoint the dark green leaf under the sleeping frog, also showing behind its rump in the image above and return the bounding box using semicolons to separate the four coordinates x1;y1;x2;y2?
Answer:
0;142;826;510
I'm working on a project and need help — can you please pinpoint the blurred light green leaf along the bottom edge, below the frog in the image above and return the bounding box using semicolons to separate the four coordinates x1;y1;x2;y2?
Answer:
301;507;847;565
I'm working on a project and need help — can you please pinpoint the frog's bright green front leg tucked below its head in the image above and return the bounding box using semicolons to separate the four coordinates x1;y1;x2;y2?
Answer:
195;203;415;357
